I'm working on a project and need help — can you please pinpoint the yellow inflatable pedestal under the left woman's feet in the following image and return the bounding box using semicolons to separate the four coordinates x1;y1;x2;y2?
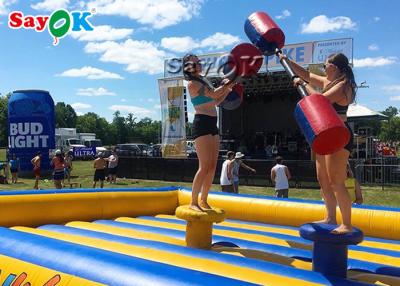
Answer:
175;205;225;249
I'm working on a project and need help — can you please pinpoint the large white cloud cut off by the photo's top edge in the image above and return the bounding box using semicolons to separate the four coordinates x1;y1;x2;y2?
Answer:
87;0;204;29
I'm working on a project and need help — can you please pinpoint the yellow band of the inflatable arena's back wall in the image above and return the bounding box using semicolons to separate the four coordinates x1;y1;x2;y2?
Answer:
0;189;400;240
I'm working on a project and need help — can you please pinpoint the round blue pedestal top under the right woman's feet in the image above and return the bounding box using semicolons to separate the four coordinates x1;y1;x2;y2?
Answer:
300;223;364;245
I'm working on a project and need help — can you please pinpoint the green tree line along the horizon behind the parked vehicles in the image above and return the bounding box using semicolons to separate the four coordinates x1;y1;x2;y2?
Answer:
0;93;400;147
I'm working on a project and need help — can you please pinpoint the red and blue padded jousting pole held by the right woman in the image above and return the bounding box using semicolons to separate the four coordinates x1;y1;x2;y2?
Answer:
244;12;350;155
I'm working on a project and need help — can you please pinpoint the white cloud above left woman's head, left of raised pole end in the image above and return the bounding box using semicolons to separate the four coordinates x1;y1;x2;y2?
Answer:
161;32;240;53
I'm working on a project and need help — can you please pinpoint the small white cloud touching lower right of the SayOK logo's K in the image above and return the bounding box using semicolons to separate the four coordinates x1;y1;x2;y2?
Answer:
70;25;133;42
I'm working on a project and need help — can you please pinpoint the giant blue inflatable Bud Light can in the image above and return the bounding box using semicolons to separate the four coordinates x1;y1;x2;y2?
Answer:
8;90;55;171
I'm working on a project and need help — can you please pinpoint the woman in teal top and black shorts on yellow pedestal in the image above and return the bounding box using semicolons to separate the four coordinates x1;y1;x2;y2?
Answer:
183;54;235;211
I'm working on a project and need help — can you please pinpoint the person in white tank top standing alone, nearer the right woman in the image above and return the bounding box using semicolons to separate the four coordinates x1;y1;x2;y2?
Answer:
271;156;291;198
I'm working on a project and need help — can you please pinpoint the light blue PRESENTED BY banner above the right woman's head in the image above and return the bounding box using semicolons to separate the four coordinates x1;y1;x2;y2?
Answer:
313;38;353;64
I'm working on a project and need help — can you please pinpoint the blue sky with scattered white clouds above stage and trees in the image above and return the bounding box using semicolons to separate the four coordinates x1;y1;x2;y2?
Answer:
0;0;400;120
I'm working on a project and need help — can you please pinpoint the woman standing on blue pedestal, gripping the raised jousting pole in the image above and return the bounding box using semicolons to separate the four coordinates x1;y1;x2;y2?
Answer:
280;53;357;234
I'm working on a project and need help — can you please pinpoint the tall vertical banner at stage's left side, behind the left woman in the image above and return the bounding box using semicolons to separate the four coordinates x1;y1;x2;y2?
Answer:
158;79;186;158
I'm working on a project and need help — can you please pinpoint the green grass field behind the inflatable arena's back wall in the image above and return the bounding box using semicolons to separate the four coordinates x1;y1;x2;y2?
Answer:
0;149;400;207
